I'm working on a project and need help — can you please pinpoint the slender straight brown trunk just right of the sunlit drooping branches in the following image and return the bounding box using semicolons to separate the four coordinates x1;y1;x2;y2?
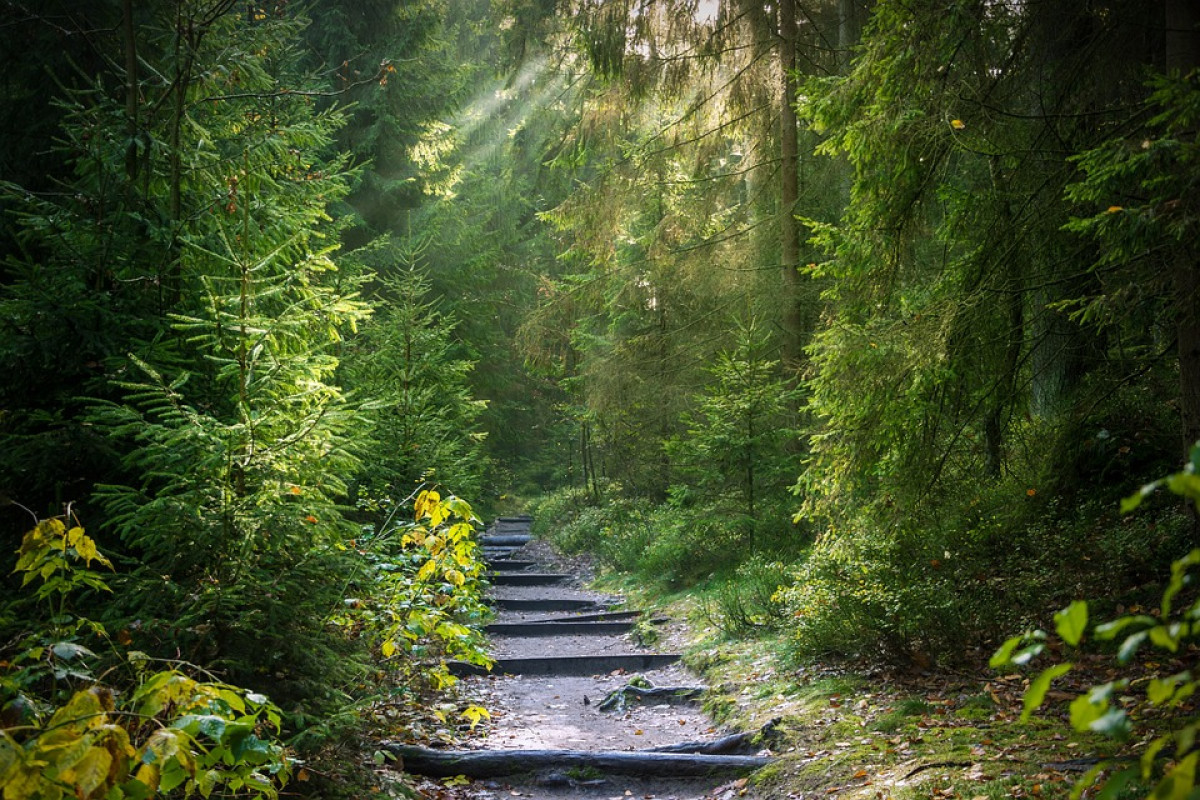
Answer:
779;0;804;374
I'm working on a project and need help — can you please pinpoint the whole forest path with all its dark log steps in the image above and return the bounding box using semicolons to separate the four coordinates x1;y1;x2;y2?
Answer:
388;517;768;800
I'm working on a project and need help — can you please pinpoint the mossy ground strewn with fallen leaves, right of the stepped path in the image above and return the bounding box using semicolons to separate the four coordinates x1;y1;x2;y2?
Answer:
595;578;1148;800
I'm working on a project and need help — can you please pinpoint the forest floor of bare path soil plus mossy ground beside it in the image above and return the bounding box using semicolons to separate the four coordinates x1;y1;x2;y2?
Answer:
396;532;1172;800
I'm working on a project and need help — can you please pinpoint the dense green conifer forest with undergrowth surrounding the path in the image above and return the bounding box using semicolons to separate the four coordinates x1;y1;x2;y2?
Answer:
0;0;1200;796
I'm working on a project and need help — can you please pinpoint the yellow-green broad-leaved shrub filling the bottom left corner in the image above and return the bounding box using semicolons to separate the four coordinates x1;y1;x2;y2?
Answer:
0;518;292;800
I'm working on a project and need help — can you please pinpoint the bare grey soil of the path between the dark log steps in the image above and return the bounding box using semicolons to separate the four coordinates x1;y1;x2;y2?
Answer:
430;532;777;800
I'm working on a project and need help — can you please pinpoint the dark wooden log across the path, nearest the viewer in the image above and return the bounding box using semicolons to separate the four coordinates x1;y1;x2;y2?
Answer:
382;742;772;778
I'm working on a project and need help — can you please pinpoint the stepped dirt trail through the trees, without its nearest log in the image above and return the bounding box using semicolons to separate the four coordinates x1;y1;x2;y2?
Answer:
406;518;766;800
